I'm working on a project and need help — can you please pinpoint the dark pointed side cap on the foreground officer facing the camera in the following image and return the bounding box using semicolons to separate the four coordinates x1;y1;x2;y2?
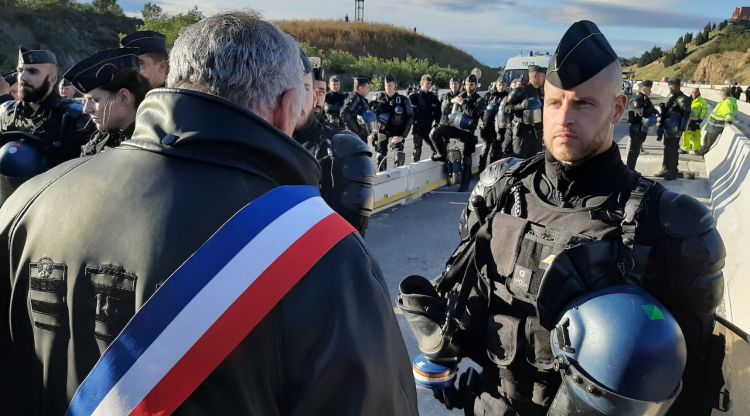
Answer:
547;20;617;90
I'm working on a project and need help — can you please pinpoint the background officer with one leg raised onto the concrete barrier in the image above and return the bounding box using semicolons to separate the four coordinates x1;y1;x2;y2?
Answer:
432;74;482;192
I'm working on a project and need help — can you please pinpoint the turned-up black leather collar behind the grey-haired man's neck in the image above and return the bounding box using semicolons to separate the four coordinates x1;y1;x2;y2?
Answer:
122;88;321;185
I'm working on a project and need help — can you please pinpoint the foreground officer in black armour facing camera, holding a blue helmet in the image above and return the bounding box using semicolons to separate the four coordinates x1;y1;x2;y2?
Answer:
398;21;725;416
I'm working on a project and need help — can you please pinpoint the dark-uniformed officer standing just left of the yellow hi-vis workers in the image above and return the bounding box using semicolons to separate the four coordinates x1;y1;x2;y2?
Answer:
654;79;692;181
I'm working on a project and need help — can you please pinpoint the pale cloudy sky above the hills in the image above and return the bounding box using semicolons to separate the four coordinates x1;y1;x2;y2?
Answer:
114;0;738;67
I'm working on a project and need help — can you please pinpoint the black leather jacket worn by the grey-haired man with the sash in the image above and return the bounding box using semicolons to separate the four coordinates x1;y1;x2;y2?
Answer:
0;89;417;416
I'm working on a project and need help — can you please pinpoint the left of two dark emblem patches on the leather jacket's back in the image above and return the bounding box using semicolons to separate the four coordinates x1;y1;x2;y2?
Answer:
29;257;68;331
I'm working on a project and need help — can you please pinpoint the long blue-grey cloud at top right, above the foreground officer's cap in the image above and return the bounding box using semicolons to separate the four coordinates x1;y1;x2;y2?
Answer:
534;0;718;29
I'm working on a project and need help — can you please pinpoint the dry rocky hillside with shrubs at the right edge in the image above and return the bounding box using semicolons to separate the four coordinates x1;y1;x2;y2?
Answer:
631;22;750;84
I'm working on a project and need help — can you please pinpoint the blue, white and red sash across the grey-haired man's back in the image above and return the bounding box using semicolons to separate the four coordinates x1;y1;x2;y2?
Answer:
67;186;354;416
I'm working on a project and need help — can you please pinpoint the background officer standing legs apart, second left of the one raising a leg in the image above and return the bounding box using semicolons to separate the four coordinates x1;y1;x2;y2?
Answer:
369;74;414;172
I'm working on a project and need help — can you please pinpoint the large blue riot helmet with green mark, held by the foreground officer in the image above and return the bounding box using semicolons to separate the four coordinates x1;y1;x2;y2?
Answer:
548;284;687;416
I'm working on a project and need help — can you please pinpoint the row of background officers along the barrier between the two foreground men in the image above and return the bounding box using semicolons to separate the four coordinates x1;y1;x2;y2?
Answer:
323;66;545;192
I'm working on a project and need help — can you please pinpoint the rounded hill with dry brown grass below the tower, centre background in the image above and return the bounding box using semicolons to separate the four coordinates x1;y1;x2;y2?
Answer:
275;20;497;84
